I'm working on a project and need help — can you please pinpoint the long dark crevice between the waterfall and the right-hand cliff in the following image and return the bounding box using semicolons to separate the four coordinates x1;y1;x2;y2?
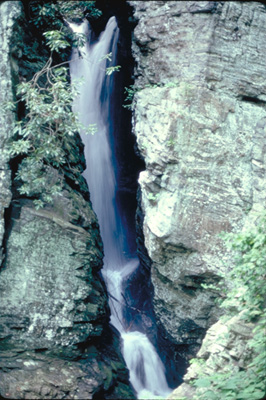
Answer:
100;1;160;354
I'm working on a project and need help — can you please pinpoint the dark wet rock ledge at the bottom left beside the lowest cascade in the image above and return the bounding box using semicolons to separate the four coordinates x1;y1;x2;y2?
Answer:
0;331;134;400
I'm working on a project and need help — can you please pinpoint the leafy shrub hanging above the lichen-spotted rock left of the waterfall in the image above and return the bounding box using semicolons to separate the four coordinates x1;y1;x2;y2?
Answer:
9;58;86;206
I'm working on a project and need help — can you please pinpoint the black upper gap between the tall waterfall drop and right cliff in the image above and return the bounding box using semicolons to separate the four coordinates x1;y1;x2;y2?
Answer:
91;0;145;254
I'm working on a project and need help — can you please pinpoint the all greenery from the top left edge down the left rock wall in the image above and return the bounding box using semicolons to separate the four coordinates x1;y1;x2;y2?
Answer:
8;1;101;207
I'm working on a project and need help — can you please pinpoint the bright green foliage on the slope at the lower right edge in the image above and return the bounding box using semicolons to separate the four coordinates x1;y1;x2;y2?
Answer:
190;214;266;400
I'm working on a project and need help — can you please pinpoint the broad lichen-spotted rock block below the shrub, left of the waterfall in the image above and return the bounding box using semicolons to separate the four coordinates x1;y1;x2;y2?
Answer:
0;195;108;349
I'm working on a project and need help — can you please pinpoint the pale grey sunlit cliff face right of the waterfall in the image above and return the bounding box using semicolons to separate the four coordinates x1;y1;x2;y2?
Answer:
130;1;266;355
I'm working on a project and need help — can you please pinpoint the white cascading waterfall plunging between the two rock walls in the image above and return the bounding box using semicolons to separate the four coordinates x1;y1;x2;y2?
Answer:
69;17;171;399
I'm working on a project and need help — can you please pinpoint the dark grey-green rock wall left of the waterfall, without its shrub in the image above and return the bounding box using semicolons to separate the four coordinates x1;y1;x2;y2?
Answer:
0;1;134;399
